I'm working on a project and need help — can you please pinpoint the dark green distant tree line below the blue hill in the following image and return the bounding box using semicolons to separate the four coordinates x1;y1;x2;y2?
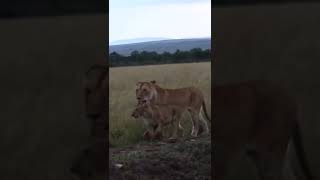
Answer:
109;48;211;67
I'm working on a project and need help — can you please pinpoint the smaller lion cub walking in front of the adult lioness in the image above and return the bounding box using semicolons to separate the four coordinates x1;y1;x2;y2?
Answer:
132;102;184;140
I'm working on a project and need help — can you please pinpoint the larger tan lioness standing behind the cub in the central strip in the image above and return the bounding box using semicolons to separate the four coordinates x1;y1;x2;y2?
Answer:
136;81;210;137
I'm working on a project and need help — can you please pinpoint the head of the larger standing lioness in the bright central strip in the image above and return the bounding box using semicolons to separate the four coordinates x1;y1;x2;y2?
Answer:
136;81;156;103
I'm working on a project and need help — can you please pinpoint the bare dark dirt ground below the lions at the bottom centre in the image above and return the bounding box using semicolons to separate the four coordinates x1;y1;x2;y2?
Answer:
109;137;211;180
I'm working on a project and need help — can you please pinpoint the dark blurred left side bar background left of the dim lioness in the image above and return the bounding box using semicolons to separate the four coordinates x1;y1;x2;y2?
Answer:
0;0;108;180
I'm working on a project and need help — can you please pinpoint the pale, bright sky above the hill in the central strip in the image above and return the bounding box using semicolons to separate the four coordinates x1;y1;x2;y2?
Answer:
109;0;211;42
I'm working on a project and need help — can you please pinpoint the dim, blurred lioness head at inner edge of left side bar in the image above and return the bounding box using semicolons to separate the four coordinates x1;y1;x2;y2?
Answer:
84;65;108;119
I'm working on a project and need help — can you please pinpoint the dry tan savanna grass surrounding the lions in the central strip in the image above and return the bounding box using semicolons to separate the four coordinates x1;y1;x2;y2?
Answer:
109;62;211;146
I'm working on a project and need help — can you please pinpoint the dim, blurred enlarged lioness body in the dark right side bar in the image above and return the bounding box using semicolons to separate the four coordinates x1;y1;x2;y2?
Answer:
212;81;313;180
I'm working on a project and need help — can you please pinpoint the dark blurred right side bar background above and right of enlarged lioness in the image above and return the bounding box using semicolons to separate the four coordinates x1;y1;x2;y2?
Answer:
212;0;320;177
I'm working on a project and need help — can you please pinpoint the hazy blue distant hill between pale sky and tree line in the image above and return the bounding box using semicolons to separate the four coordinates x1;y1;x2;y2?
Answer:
109;38;211;56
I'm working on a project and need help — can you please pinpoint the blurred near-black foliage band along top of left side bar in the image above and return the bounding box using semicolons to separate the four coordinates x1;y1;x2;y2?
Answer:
0;0;109;18
